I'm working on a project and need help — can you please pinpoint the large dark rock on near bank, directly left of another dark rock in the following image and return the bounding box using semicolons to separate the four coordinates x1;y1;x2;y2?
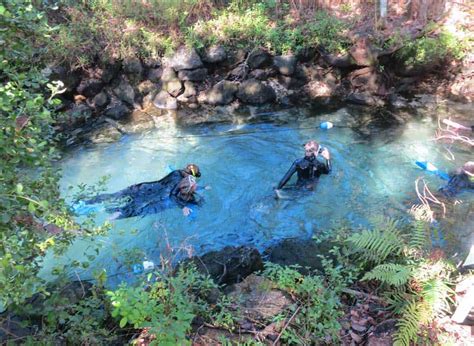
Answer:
184;246;263;284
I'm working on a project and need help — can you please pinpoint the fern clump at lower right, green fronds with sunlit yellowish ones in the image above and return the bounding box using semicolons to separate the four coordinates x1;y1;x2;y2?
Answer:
348;220;455;345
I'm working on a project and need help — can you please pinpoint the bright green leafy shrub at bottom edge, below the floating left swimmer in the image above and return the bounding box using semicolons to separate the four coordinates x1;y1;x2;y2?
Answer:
107;268;215;345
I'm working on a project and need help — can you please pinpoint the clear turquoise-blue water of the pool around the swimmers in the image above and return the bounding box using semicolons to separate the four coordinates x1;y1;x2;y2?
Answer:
45;109;472;280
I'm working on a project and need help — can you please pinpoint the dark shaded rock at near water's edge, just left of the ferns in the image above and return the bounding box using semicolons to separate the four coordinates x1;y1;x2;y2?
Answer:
264;239;334;271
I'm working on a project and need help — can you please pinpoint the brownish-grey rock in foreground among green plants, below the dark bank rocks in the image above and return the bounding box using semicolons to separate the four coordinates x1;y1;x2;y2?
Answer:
228;274;294;322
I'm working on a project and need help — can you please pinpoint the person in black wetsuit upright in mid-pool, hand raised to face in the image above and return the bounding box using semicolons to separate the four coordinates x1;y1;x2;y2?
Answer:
275;141;331;194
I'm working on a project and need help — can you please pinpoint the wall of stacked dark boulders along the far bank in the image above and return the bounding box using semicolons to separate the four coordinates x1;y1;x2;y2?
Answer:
50;43;474;146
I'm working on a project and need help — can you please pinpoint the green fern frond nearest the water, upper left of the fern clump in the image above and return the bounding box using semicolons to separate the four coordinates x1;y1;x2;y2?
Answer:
348;228;404;264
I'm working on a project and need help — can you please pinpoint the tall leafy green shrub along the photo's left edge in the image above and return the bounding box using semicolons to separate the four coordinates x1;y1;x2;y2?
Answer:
0;0;108;307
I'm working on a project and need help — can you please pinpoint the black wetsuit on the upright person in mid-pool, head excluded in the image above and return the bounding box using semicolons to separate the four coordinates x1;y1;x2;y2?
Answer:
277;156;331;189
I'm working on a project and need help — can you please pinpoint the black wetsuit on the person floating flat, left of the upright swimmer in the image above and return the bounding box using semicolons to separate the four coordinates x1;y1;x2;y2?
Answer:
86;170;201;219
